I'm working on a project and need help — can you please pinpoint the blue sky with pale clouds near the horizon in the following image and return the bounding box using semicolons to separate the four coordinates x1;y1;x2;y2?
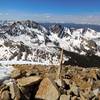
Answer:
0;0;100;24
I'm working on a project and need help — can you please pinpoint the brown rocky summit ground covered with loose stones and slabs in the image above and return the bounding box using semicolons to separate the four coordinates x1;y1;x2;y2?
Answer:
0;65;100;100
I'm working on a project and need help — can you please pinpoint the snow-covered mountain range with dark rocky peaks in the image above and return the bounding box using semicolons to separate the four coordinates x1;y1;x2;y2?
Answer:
0;20;100;64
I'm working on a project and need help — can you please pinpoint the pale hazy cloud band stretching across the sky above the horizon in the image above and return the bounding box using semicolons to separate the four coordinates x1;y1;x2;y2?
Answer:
0;12;100;25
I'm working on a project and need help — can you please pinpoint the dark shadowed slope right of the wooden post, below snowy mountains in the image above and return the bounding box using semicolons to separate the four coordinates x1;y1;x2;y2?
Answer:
64;51;100;67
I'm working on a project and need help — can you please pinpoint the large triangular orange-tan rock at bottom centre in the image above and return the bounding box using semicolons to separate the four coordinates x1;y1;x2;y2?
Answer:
35;78;60;100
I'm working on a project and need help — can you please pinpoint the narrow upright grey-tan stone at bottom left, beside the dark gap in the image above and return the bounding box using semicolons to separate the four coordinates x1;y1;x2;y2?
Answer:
9;83;21;100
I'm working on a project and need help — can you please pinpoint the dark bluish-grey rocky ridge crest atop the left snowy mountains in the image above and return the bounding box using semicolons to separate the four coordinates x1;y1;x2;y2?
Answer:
1;20;42;36
